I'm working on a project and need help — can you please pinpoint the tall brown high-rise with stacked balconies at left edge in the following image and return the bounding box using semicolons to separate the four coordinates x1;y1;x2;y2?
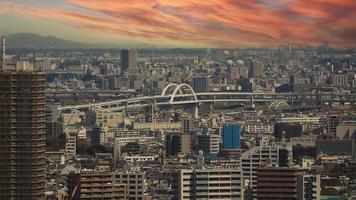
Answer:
0;71;46;199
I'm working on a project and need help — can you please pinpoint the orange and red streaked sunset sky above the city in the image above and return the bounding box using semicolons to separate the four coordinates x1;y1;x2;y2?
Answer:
0;0;356;48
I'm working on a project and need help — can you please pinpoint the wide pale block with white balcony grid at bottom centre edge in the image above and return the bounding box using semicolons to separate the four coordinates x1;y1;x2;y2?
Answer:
174;168;242;200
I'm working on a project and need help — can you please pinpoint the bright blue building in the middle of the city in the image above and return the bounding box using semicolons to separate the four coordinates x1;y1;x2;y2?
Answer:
223;124;241;149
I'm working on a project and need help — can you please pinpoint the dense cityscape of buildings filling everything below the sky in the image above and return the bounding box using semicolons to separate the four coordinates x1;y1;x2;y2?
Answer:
0;33;356;200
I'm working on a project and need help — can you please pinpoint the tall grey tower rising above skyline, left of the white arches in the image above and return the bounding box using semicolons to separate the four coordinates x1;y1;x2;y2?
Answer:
120;49;137;75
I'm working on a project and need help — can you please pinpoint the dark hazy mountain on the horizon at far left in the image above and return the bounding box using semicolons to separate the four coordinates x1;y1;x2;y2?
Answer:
5;33;88;49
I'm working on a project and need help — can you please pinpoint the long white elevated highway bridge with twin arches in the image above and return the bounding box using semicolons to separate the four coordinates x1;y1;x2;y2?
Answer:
58;83;356;111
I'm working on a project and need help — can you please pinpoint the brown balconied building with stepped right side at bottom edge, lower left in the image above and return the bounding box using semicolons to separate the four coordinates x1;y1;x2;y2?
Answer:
80;171;128;200
